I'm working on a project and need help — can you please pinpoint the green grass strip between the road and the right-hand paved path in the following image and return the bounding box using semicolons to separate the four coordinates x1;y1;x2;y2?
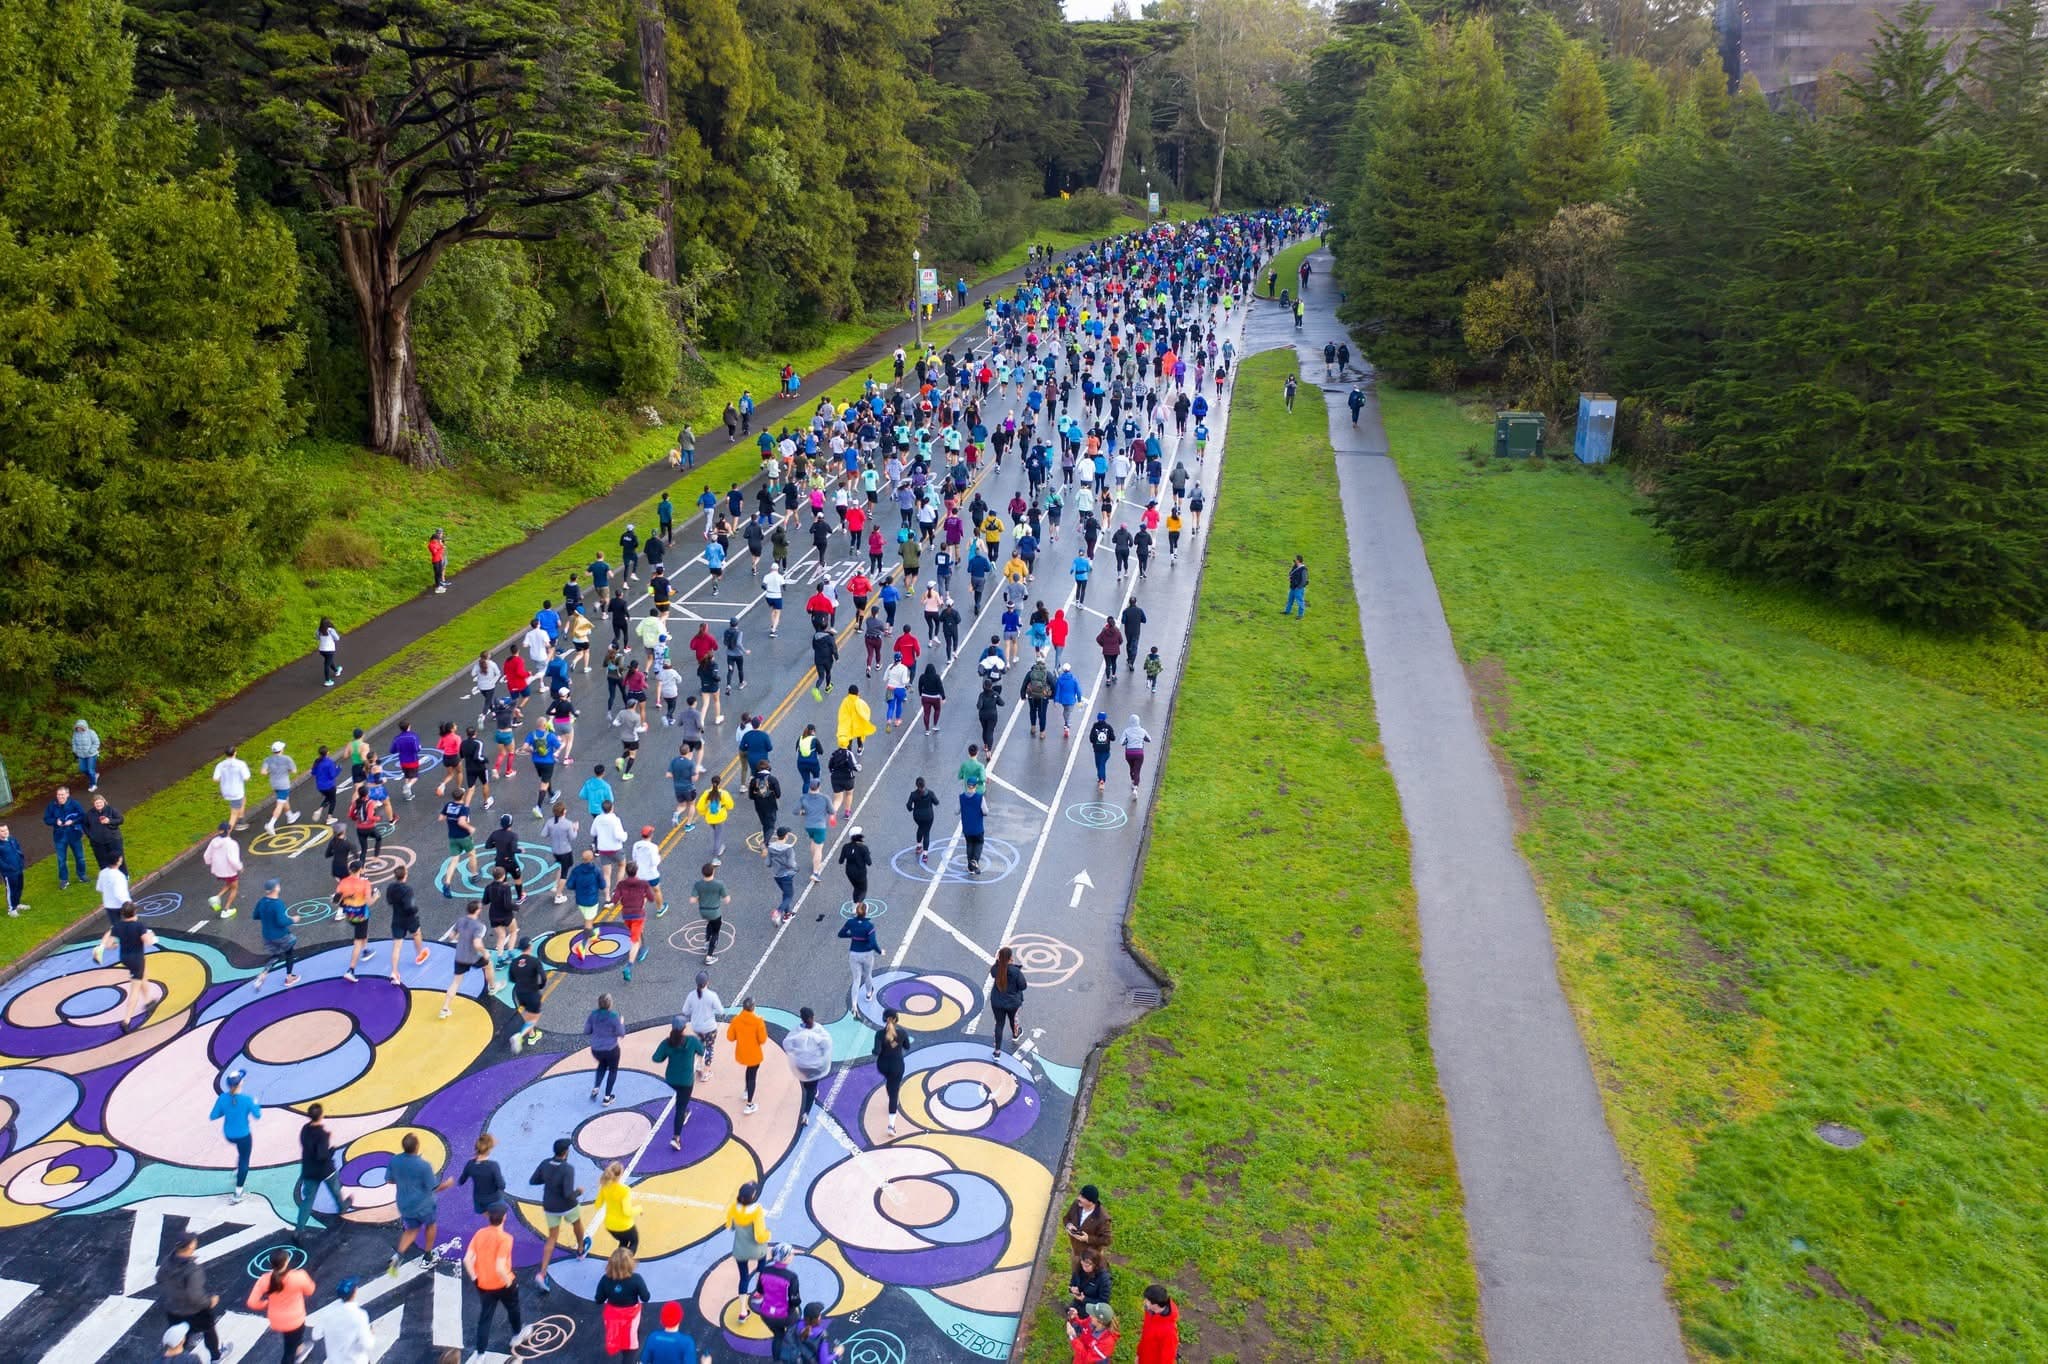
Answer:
1024;352;1483;1364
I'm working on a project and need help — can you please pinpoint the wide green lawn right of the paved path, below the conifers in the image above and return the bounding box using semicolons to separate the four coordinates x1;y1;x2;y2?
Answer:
1376;393;2048;1364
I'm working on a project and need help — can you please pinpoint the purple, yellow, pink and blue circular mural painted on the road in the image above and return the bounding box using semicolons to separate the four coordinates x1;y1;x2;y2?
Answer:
0;938;1079;1364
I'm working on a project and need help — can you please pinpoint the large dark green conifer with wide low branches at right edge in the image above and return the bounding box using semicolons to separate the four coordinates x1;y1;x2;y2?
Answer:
1653;4;2048;625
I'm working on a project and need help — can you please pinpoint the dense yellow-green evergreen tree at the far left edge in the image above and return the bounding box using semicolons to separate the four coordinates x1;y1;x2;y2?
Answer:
0;0;301;704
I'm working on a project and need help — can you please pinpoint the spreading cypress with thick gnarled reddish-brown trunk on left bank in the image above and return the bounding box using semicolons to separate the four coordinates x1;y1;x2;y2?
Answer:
129;0;645;467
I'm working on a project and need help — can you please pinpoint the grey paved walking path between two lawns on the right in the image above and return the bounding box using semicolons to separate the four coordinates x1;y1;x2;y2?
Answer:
1247;252;1686;1364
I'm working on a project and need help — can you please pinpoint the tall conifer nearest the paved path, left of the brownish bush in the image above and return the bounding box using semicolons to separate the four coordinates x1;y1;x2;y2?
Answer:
1341;23;1507;383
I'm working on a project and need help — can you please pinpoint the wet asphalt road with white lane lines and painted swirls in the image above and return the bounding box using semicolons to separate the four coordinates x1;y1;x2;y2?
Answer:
0;284;1269;1364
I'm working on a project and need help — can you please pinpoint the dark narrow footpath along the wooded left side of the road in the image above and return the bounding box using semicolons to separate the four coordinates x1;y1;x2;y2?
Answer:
74;252;1065;813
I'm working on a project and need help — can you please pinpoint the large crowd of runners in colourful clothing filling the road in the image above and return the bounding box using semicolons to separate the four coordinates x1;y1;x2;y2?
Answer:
64;211;1317;1364
